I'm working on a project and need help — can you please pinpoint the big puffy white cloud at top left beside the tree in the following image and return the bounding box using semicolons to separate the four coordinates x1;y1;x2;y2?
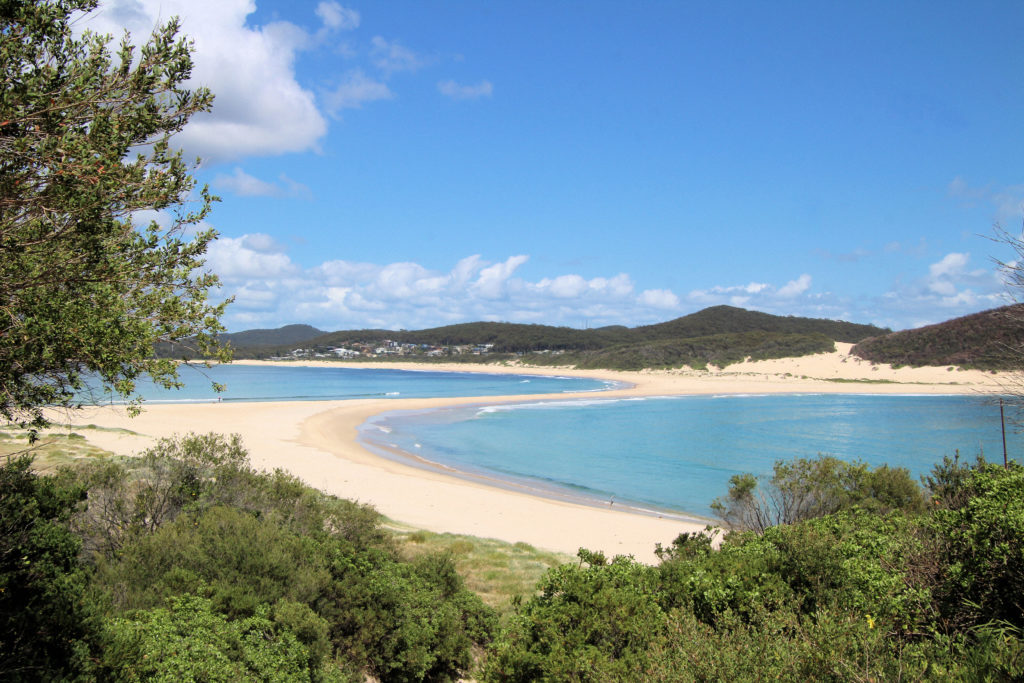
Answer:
88;0;329;161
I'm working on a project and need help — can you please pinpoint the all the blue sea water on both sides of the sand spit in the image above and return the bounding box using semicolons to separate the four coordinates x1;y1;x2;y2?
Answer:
95;365;1024;515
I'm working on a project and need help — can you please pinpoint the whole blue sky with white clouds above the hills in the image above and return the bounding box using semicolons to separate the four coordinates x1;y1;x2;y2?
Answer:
79;0;1024;331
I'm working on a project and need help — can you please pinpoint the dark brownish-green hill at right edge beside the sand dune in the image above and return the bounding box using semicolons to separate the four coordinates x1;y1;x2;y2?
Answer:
851;304;1024;370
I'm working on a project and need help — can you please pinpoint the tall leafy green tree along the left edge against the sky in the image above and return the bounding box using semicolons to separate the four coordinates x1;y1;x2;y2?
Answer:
0;0;226;427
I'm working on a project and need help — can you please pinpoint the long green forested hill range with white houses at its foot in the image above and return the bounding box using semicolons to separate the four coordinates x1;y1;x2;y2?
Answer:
214;306;888;370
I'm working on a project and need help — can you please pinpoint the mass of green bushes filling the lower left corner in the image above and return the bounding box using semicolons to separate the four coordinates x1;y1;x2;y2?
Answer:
0;435;496;681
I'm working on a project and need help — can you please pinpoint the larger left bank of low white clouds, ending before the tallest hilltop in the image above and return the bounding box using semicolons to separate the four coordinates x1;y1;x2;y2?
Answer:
207;244;682;330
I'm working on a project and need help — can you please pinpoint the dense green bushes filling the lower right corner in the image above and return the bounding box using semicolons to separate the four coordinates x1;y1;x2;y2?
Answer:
481;461;1024;681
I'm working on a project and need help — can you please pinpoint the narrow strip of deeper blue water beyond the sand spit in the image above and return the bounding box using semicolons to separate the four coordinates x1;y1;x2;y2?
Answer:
81;365;616;403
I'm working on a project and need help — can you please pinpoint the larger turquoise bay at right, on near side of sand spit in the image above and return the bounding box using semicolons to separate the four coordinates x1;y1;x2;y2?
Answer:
362;394;1022;515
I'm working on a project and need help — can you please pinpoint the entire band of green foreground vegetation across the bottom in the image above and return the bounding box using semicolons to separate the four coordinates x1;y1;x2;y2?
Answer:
0;435;1024;681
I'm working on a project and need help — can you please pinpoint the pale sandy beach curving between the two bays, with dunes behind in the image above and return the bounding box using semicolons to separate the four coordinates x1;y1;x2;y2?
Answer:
46;344;1011;561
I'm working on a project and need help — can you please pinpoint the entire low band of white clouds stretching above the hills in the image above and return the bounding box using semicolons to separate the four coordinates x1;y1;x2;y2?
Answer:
207;240;1008;330
